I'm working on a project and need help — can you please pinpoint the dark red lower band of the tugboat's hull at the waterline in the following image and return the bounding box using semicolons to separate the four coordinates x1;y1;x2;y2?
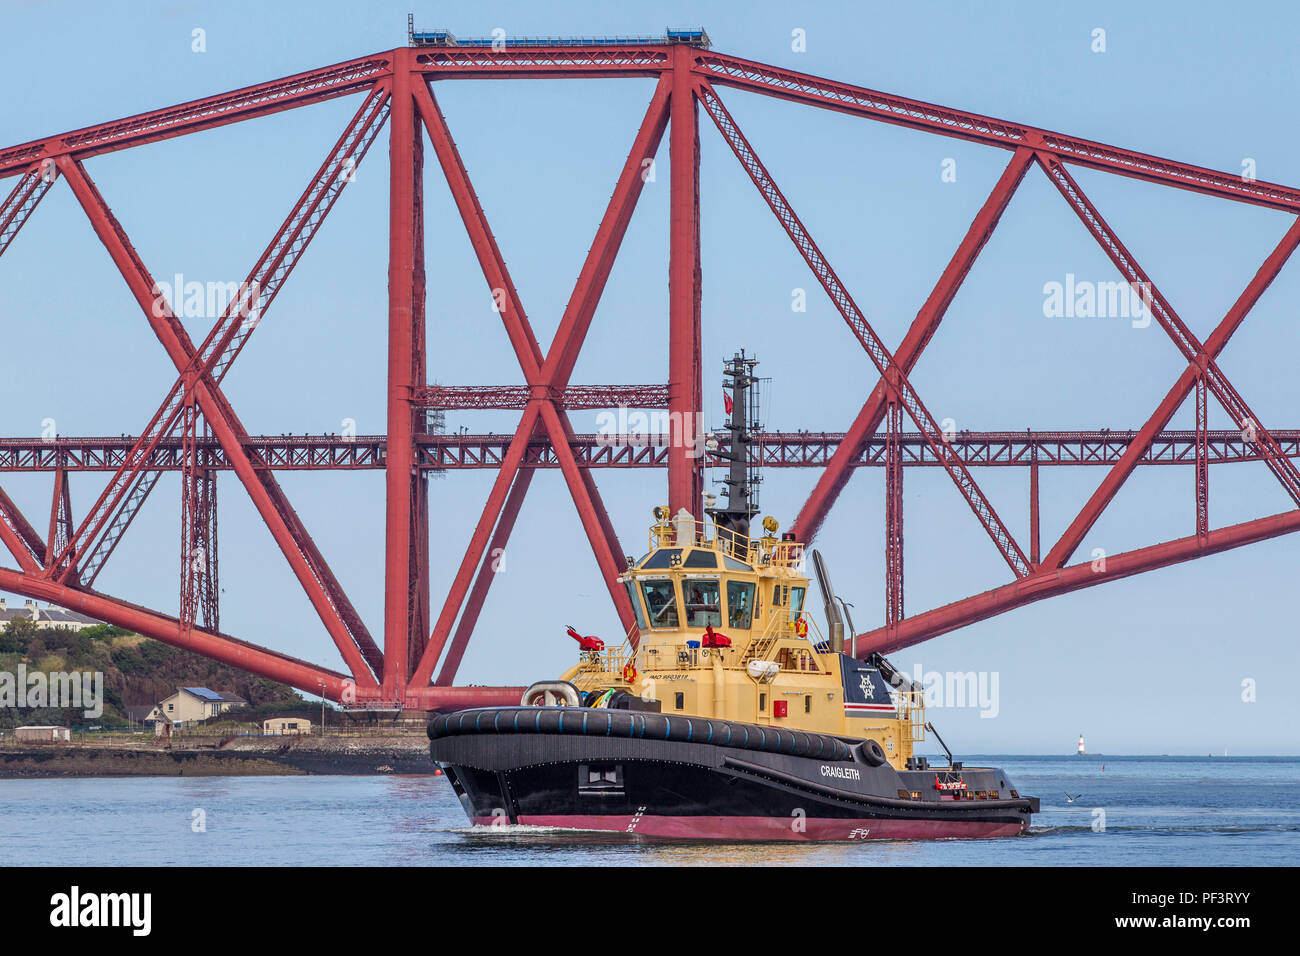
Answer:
473;814;1028;842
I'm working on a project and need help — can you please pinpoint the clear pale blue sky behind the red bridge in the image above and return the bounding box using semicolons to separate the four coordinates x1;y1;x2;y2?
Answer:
0;1;1300;753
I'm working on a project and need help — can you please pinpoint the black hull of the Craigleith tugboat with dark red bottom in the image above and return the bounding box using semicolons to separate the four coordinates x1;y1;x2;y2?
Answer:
429;708;1037;840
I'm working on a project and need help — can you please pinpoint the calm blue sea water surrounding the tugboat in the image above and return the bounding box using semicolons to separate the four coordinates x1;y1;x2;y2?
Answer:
0;756;1300;866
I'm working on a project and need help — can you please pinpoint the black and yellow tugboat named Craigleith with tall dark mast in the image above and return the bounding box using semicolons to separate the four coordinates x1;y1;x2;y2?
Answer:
428;352;1039;840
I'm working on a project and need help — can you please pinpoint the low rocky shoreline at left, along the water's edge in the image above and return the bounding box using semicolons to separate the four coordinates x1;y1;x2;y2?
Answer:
0;736;434;779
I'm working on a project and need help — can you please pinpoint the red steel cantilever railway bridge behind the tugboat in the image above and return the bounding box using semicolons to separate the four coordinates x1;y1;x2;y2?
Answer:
0;31;1300;709
